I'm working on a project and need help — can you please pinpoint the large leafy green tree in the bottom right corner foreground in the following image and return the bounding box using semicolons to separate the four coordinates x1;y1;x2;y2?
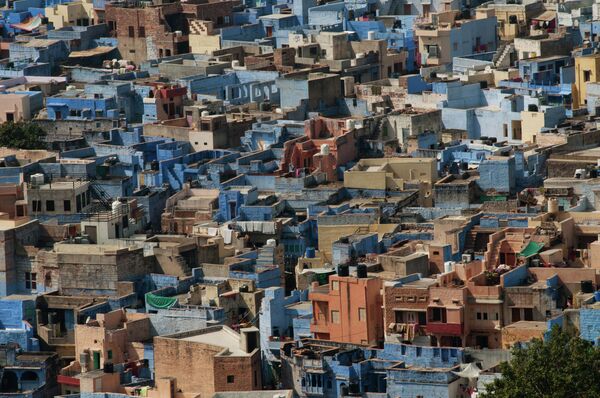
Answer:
481;327;600;398
